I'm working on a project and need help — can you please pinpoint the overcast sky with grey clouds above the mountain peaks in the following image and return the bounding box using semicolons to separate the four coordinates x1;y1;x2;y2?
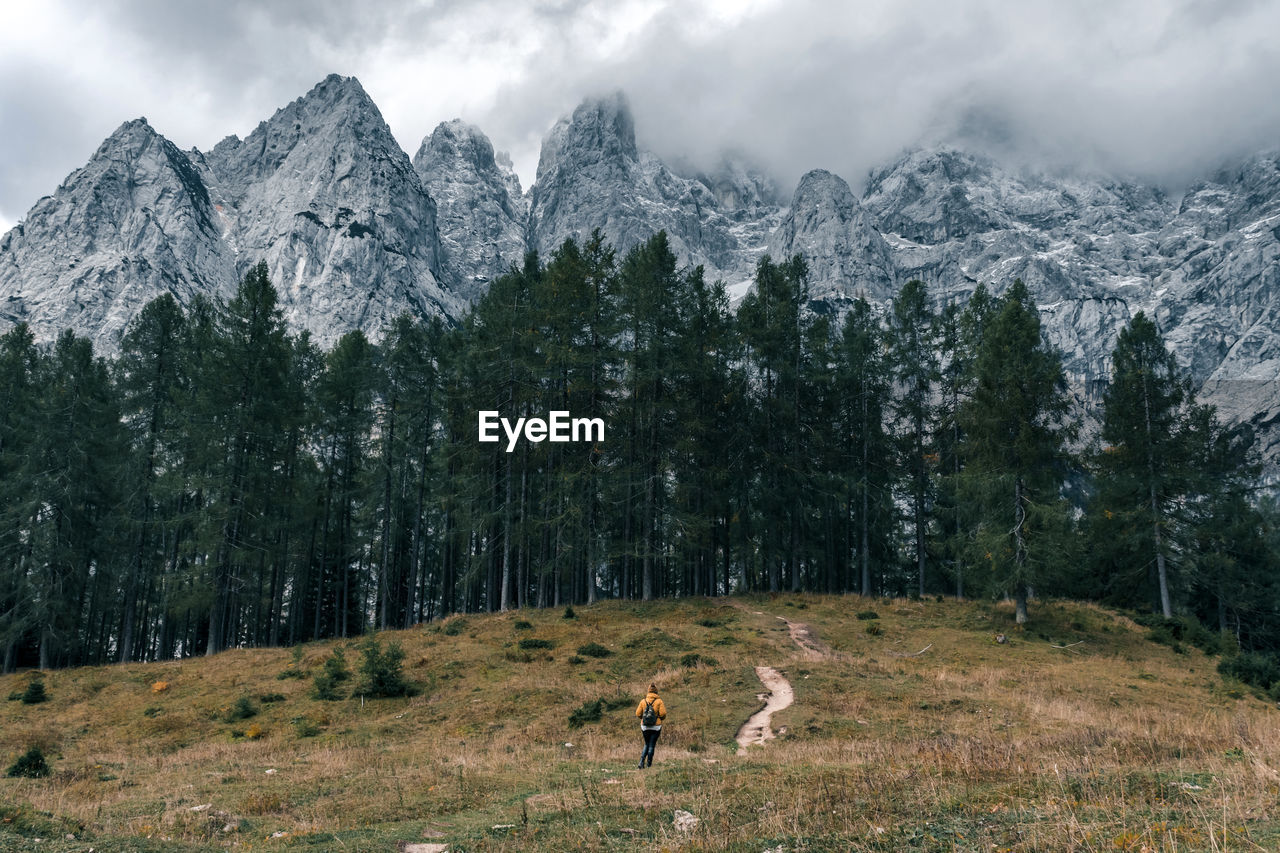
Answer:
0;0;1280;233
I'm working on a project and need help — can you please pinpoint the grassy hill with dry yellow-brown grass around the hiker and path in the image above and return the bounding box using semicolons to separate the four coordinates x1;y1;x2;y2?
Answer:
0;594;1280;852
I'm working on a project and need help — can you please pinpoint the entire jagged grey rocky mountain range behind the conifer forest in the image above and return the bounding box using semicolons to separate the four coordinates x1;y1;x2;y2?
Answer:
0;76;1280;460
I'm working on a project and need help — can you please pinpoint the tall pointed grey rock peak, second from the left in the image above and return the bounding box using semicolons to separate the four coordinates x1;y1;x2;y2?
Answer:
193;74;463;343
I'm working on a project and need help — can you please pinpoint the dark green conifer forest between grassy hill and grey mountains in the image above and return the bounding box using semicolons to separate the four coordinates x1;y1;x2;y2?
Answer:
0;233;1280;671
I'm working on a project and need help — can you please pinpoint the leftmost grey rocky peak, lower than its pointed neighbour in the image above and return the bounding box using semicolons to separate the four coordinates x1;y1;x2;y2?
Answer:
0;119;236;350
